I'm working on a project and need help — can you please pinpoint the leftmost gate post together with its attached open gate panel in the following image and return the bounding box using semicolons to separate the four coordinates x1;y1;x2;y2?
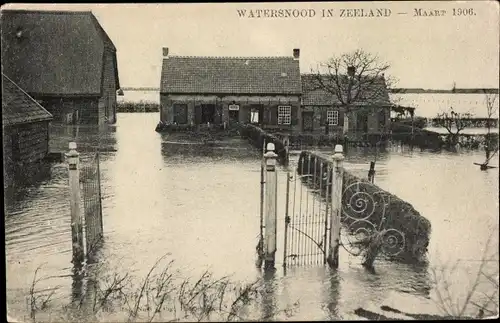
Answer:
66;142;103;265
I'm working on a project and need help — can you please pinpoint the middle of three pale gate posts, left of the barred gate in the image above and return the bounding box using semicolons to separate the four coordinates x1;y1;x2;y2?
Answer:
264;142;278;270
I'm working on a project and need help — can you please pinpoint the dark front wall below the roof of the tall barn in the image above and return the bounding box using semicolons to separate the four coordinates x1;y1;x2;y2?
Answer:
34;97;99;124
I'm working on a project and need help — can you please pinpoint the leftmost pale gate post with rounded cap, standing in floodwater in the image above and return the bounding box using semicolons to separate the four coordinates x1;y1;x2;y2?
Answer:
65;142;84;264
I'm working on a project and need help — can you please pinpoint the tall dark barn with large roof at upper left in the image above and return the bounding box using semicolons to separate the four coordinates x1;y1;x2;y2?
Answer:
1;10;120;124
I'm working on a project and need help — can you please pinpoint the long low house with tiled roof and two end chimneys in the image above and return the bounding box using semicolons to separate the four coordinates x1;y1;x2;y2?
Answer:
160;48;302;130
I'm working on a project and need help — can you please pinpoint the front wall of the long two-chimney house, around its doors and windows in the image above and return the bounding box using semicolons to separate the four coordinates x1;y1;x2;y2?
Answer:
160;94;302;130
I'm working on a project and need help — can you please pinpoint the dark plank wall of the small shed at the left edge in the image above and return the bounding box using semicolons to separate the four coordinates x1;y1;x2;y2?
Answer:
3;121;49;181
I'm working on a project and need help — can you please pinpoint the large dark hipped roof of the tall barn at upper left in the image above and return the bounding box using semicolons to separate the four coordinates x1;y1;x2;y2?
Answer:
1;10;118;96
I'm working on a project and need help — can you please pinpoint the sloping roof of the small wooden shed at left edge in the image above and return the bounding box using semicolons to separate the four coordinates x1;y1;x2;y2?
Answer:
2;74;52;127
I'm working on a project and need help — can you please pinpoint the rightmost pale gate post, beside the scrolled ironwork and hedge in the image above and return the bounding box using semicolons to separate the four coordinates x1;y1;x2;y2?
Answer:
327;145;344;269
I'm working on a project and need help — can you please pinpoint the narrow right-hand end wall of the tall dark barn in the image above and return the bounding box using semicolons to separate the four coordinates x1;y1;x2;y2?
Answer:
98;48;117;124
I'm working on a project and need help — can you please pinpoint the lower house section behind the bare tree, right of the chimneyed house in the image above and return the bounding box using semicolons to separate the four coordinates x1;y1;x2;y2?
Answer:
301;74;393;139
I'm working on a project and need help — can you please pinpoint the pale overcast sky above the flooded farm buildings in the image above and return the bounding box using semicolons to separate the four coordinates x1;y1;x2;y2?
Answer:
3;1;500;88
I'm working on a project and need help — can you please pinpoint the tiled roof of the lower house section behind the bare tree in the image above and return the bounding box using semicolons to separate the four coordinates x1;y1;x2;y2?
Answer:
301;74;391;106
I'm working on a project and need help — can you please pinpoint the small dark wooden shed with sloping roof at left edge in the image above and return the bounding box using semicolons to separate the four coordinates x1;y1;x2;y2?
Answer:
2;74;52;186
